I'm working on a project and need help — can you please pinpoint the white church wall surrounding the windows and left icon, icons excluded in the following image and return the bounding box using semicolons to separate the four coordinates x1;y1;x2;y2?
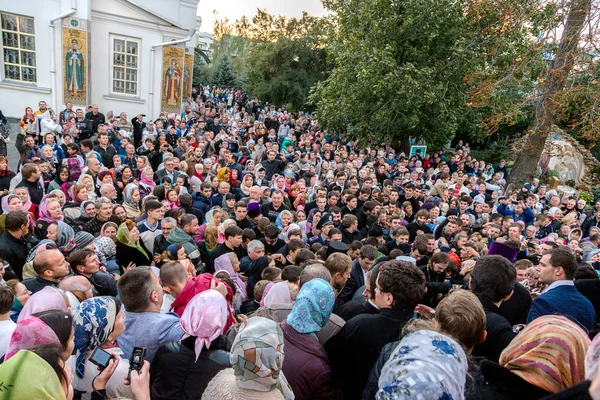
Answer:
0;0;199;118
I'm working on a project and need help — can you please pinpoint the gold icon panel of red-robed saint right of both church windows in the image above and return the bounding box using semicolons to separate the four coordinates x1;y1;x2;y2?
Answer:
161;46;185;114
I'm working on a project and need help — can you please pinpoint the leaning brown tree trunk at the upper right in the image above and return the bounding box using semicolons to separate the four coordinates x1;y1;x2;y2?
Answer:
506;0;592;191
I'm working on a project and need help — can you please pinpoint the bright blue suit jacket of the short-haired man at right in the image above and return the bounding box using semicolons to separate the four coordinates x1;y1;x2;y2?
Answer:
527;285;596;331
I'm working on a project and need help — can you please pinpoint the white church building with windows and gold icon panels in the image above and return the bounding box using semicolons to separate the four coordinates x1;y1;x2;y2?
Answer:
0;0;201;118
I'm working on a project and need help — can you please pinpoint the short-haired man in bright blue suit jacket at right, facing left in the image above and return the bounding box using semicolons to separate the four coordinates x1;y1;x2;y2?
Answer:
527;246;596;330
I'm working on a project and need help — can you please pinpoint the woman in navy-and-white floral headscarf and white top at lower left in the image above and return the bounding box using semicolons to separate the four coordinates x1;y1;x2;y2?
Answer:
68;296;132;400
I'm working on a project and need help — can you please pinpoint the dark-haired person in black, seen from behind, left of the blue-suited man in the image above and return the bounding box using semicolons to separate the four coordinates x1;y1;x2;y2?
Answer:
469;255;517;362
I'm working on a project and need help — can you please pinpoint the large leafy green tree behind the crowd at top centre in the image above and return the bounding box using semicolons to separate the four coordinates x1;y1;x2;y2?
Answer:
310;0;476;147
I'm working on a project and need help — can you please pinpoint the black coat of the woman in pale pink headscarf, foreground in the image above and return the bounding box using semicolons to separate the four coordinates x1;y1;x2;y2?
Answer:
150;336;231;400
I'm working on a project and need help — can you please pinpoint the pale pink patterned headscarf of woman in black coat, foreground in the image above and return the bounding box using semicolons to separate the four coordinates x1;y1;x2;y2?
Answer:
179;289;229;360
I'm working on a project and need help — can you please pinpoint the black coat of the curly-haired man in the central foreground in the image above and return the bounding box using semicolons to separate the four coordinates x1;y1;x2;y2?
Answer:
325;308;413;400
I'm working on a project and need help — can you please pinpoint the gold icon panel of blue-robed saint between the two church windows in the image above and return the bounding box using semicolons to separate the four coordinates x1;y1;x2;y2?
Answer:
62;20;88;105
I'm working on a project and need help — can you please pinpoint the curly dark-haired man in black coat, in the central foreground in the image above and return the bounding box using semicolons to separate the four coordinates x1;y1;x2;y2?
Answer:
325;260;425;400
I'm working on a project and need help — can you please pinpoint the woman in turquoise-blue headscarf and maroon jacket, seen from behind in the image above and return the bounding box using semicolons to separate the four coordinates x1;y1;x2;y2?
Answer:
281;278;338;400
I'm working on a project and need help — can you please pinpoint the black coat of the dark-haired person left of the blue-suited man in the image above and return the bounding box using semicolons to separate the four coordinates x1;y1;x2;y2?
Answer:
473;295;515;362
